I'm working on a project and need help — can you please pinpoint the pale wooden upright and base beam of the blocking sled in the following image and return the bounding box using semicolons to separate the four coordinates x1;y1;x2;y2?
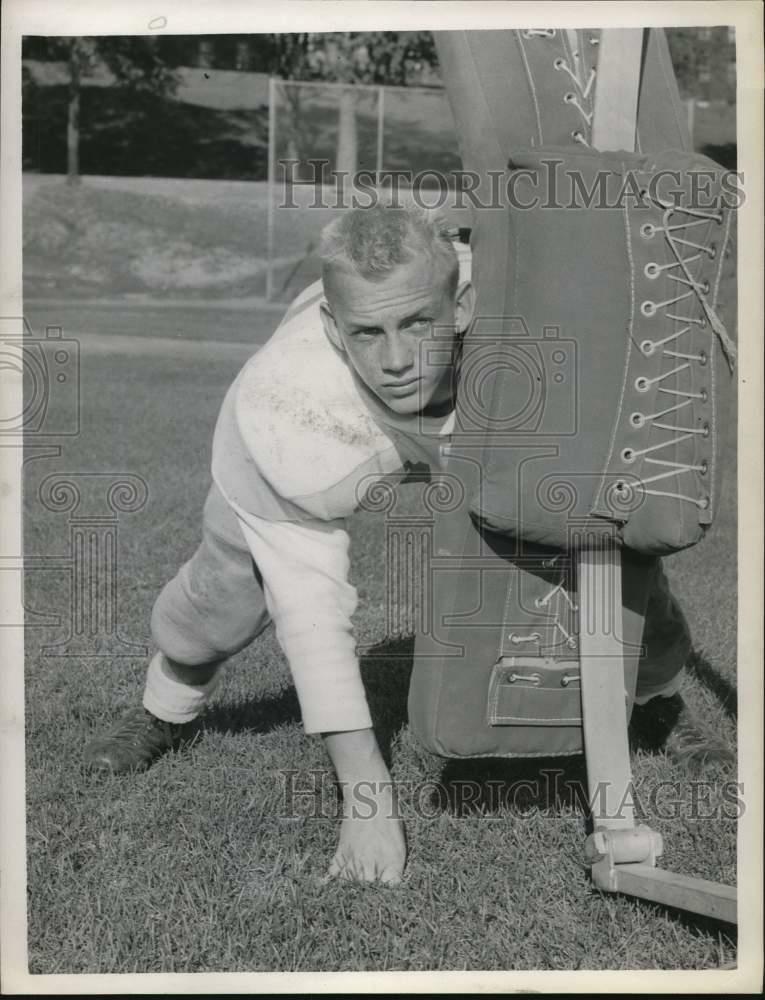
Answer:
576;29;737;923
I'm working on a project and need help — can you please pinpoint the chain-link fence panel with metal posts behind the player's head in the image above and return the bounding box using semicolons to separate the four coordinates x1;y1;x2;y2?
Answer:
266;78;468;301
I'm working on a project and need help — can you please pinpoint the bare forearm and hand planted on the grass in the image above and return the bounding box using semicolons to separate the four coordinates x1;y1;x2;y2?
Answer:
324;729;406;885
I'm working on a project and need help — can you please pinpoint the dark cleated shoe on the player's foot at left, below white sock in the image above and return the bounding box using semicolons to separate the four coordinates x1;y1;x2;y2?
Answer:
84;708;183;774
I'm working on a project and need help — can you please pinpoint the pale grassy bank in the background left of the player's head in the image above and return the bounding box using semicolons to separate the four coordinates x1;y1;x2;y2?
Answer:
24;174;470;304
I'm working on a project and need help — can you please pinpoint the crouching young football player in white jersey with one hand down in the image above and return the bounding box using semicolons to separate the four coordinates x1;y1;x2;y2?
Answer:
85;206;474;883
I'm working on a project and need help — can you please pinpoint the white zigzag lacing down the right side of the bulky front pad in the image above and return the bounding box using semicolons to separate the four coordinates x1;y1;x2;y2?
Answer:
622;202;736;510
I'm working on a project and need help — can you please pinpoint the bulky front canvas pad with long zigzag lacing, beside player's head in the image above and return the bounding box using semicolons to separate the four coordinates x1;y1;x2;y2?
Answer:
472;147;736;554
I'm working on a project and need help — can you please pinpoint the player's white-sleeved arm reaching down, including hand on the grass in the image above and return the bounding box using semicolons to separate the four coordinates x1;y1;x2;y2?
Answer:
228;508;406;883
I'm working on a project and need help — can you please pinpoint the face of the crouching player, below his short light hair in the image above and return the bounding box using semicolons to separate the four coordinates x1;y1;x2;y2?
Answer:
322;259;472;415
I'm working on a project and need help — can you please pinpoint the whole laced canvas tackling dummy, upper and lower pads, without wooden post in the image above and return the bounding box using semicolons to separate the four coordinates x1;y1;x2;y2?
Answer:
409;29;736;757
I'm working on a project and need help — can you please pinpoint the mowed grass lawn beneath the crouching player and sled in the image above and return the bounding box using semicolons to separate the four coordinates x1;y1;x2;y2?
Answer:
25;308;736;973
